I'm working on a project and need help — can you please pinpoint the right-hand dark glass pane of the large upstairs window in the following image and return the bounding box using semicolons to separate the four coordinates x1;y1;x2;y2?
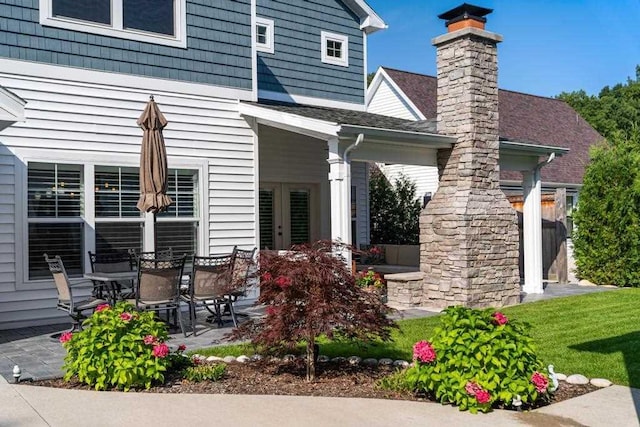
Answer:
122;0;175;36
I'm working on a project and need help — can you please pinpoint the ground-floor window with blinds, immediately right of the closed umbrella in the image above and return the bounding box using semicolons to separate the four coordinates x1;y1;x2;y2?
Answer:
156;169;199;255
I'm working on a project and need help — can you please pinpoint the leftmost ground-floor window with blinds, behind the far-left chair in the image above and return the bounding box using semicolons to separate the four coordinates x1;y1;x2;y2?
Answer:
27;163;84;279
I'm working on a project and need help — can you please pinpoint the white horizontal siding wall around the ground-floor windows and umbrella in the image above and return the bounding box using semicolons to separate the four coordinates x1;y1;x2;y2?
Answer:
0;71;257;329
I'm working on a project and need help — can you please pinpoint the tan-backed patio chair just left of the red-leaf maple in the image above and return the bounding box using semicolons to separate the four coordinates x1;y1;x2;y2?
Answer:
182;255;238;336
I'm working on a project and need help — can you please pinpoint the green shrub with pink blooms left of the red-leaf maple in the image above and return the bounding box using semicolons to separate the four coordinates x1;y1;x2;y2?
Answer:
60;303;190;391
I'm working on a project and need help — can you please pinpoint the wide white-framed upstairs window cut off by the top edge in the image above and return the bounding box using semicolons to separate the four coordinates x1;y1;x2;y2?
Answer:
40;0;187;47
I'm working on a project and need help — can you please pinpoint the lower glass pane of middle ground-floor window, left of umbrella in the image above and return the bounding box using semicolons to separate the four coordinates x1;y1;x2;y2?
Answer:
96;222;142;254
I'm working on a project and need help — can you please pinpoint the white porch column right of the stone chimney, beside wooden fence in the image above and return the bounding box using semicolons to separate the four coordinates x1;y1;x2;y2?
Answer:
522;167;544;294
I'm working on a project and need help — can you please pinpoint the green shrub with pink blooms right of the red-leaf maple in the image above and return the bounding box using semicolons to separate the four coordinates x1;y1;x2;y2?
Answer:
402;307;549;413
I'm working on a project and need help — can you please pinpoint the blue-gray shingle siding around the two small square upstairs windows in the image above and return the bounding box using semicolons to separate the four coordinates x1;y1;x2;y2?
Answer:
257;0;364;104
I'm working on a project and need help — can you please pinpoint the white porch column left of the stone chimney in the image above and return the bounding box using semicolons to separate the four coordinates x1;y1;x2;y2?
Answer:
327;138;351;266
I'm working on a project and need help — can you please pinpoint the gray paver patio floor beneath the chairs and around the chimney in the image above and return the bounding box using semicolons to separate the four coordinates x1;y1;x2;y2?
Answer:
0;283;615;382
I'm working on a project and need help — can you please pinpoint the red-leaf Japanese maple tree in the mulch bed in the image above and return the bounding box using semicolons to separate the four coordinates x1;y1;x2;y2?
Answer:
233;241;395;381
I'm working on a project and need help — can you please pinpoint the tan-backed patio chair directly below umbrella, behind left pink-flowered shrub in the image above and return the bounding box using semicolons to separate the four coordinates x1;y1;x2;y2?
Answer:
127;255;187;337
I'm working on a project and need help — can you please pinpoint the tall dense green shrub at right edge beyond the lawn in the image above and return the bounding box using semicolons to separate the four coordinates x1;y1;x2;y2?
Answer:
573;128;640;287
